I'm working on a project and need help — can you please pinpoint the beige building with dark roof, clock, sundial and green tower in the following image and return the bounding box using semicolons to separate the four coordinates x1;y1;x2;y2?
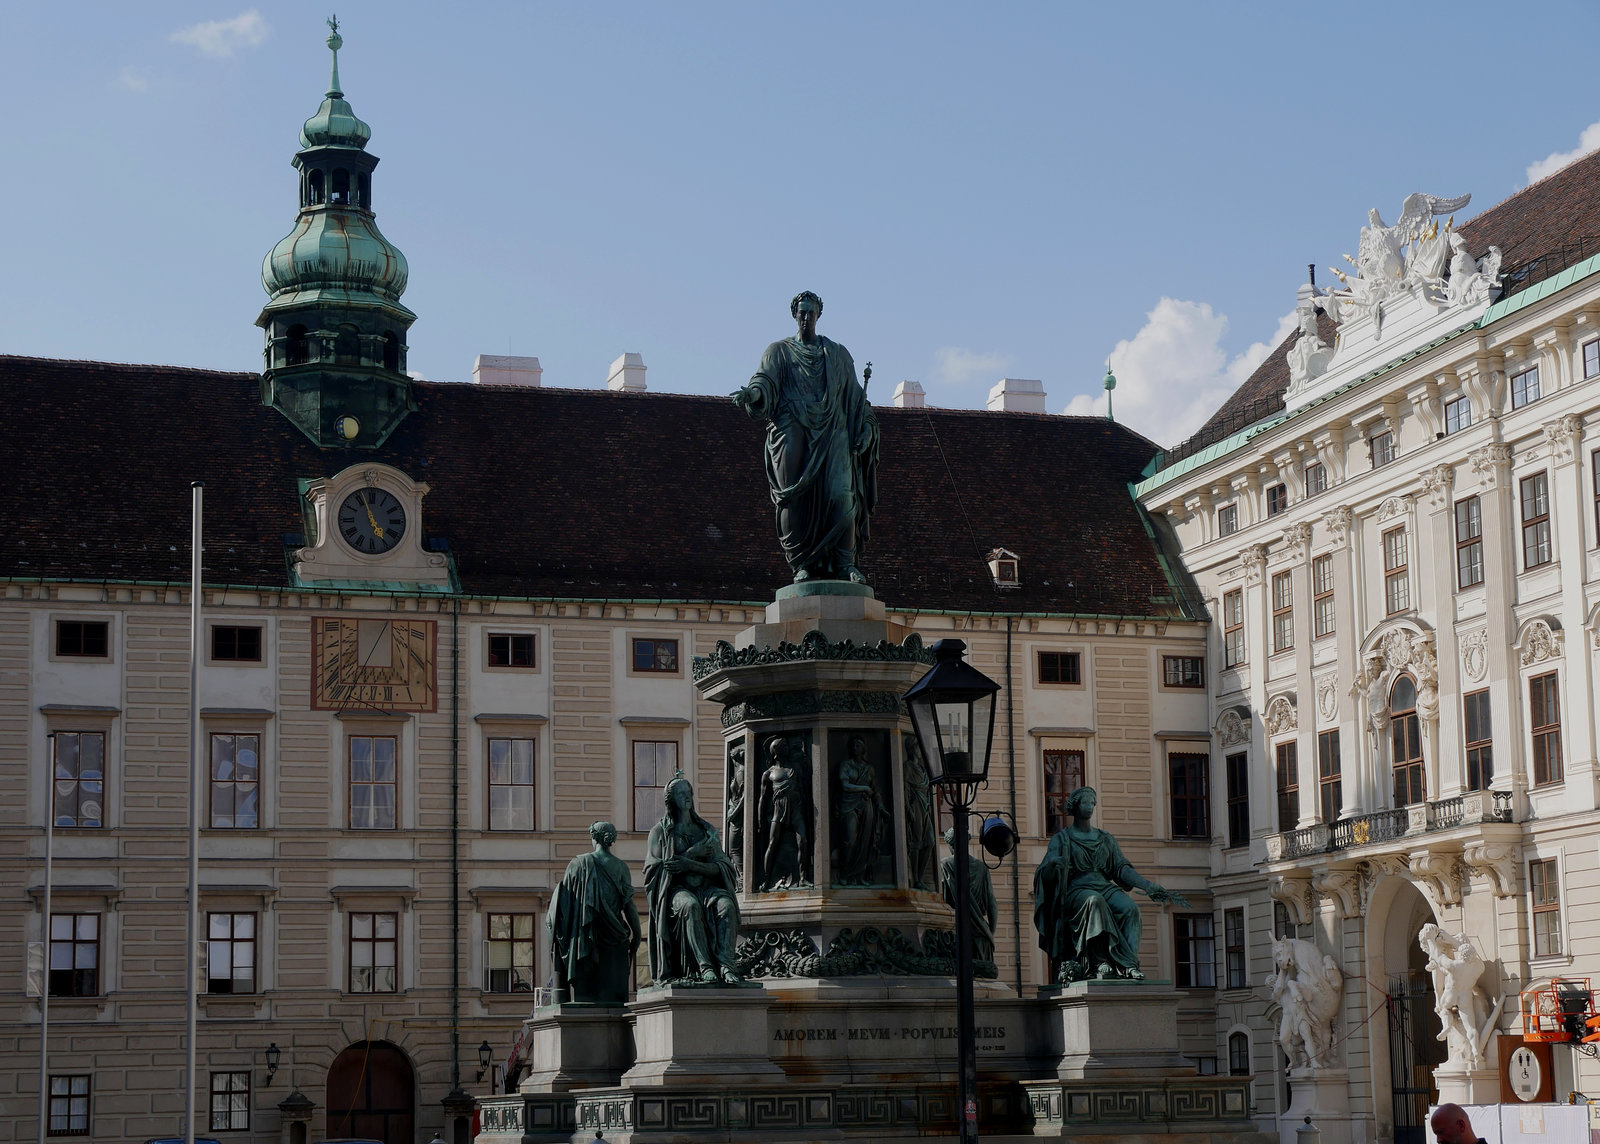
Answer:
0;26;1219;1141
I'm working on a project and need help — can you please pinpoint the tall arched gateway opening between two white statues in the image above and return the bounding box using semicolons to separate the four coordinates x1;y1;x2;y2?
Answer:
1382;883;1448;1144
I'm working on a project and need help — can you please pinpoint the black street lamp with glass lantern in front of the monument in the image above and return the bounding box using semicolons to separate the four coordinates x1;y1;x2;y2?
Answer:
906;640;1000;1144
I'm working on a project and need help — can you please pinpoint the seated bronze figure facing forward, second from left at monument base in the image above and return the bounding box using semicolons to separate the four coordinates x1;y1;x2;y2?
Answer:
645;771;742;986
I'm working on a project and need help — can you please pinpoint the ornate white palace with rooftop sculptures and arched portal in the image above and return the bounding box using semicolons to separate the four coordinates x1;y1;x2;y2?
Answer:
1136;155;1600;1141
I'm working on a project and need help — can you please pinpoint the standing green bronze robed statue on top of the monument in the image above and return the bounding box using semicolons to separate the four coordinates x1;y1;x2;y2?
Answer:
733;290;878;584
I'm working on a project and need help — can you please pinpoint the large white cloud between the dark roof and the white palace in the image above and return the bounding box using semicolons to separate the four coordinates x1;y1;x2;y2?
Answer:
1066;298;1294;446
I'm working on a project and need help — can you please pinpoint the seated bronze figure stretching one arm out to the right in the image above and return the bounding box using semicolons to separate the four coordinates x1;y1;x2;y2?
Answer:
1034;787;1189;984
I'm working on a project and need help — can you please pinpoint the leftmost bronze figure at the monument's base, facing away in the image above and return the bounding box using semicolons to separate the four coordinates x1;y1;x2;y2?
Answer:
549;822;640;1005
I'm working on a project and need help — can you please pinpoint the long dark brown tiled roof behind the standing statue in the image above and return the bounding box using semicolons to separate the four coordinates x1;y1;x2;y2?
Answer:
0;357;1196;616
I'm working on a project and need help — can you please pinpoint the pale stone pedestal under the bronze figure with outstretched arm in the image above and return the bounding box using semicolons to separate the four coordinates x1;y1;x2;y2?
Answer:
1038;981;1195;1080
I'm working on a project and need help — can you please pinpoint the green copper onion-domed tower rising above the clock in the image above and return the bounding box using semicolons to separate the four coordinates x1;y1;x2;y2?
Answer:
256;19;416;450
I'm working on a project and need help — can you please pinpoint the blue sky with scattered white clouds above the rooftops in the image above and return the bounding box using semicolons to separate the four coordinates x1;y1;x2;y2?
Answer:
0;0;1600;445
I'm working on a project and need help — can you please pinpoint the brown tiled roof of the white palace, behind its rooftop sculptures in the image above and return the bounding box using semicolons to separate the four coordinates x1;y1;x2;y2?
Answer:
1197;150;1600;435
